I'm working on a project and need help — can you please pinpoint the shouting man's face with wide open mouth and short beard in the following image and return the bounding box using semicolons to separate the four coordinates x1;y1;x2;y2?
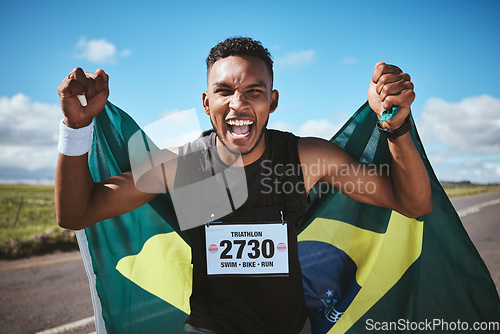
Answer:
202;56;278;164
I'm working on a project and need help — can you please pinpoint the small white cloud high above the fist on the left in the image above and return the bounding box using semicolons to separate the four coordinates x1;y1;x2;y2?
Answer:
76;37;131;64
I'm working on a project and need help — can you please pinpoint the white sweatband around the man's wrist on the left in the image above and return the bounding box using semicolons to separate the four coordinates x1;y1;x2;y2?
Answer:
57;119;94;157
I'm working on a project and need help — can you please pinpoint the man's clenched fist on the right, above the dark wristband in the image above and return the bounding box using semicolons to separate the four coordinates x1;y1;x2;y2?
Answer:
368;62;415;129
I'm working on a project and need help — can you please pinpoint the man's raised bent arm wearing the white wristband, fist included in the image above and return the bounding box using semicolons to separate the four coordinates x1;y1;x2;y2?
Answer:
55;68;155;230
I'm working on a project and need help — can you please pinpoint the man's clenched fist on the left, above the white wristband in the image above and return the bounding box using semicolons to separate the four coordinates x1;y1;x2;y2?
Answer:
57;67;109;128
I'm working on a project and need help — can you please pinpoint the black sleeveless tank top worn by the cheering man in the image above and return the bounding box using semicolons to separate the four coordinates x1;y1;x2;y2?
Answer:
176;130;308;334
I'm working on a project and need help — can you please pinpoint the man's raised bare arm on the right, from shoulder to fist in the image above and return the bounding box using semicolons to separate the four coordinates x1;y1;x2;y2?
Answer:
299;62;432;217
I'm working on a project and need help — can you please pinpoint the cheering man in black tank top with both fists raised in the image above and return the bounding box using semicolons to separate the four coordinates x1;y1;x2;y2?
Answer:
55;38;432;333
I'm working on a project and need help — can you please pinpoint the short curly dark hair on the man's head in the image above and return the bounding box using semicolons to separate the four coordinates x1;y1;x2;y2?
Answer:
206;37;274;87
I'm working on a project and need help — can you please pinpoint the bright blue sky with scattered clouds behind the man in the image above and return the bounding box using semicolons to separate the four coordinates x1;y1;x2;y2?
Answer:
0;0;500;183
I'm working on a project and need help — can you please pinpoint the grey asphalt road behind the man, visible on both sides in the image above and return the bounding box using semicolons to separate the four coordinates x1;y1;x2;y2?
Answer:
0;193;500;334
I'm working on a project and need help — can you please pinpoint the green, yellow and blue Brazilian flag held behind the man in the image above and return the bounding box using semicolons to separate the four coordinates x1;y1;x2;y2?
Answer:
77;102;500;334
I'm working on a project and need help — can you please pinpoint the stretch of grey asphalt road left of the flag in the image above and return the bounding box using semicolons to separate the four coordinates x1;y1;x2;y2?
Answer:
0;251;95;333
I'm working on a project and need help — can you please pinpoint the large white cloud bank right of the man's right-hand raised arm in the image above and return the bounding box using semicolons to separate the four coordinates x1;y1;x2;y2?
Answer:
417;95;500;183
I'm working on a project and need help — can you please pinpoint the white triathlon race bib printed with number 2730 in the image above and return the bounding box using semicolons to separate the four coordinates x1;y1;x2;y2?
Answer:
205;222;288;276
